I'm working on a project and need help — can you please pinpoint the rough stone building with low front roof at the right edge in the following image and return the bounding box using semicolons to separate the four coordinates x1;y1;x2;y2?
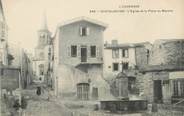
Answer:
139;39;184;104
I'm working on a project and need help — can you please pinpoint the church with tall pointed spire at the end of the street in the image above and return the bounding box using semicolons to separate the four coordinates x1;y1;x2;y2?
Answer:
33;15;53;86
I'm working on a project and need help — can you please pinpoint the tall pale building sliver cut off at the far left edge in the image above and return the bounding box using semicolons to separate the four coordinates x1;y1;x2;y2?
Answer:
0;0;8;65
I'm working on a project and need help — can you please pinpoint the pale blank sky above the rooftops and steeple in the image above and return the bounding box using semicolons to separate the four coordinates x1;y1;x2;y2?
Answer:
2;0;184;52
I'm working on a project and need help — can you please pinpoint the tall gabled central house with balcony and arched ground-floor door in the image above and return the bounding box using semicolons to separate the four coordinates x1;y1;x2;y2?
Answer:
54;17;110;99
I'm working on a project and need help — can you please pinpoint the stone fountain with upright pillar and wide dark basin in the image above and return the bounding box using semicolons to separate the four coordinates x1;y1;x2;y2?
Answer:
100;72;147;112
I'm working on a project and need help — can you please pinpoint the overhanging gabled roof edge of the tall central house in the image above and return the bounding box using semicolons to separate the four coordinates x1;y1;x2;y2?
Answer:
58;16;108;28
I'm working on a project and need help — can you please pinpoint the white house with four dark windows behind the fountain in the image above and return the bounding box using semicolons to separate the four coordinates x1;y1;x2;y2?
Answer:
103;40;152;94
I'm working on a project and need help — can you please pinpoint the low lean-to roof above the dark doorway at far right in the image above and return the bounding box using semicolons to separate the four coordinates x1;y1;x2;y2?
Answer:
140;64;184;72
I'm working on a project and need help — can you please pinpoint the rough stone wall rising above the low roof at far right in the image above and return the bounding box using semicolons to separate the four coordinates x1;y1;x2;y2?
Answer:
150;40;184;65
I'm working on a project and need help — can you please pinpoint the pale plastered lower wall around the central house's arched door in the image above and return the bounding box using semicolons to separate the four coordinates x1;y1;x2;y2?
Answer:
57;65;113;100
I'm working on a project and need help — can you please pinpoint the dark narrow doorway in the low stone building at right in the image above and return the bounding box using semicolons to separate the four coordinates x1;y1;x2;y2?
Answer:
153;80;163;103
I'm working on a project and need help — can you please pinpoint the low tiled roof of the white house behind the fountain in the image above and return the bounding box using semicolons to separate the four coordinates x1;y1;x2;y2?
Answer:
105;42;150;49
